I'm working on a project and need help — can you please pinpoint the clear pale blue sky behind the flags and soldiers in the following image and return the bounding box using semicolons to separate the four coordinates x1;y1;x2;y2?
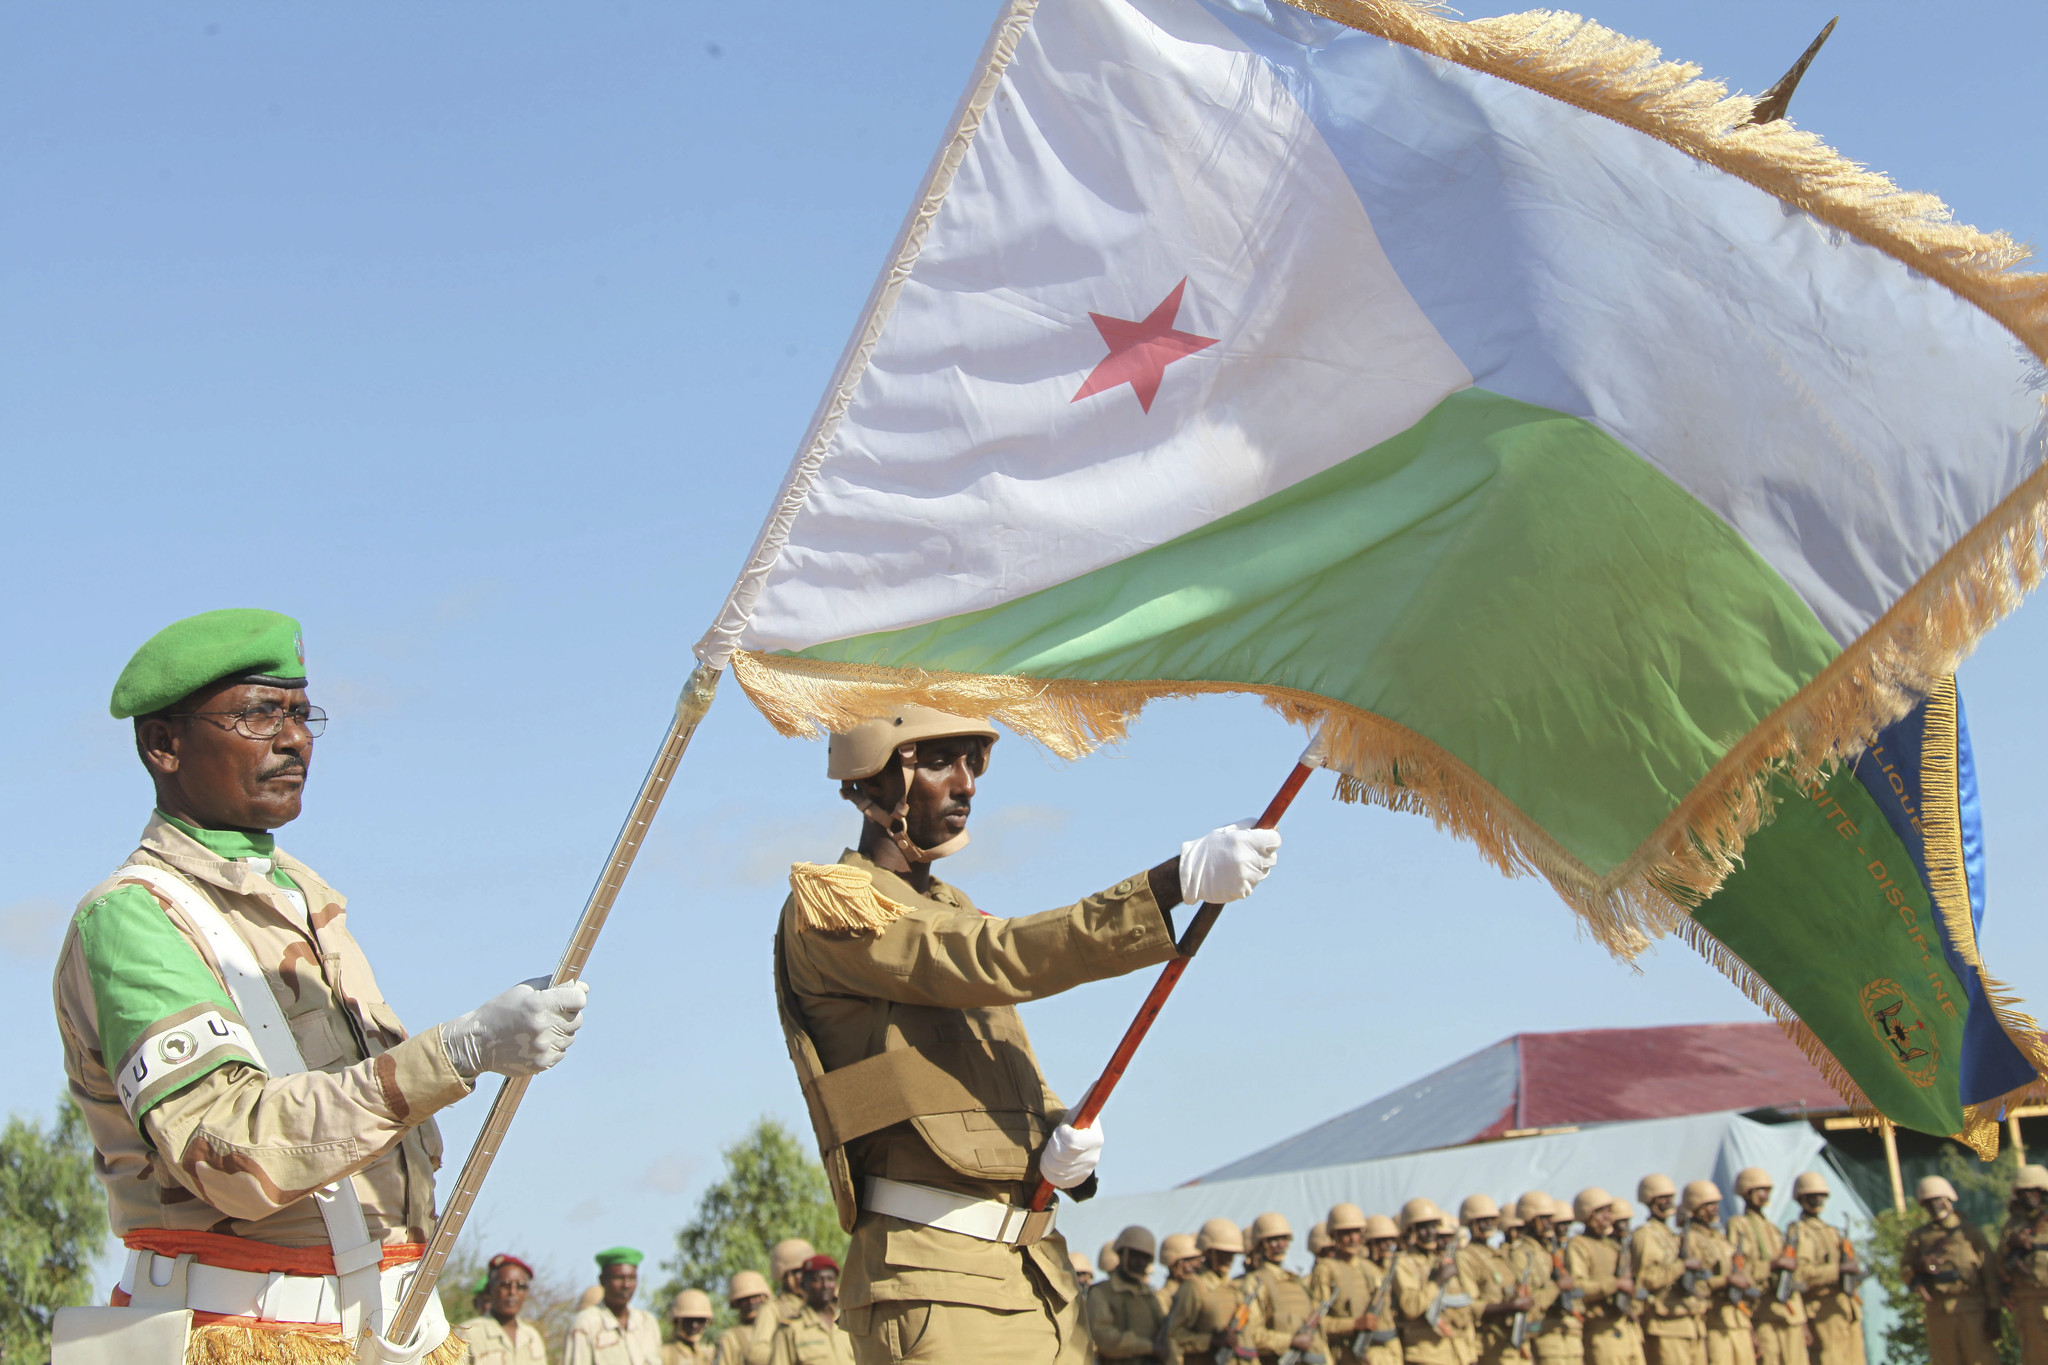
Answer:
0;0;2048;1301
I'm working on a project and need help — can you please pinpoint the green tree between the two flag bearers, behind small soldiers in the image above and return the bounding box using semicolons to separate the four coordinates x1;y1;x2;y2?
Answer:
653;1117;846;1330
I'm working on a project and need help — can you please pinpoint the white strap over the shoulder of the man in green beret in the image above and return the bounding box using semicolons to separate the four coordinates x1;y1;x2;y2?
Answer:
119;862;383;1338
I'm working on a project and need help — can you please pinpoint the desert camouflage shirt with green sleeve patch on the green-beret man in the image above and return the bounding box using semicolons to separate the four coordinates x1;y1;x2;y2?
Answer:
55;814;469;1246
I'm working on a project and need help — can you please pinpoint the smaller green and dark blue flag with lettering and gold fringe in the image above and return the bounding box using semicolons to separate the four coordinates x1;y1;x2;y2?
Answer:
1683;679;2048;1158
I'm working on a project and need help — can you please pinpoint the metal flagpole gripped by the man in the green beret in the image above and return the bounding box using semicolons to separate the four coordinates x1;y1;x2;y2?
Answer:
385;663;723;1342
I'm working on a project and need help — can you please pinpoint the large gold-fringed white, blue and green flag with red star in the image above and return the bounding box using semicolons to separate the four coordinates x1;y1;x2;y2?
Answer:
698;0;2048;1121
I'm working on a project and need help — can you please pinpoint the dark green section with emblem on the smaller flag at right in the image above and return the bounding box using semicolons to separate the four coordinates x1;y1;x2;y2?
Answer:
1692;767;1966;1136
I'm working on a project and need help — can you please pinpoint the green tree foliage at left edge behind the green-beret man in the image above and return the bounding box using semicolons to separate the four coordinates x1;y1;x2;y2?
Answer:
0;1095;106;1361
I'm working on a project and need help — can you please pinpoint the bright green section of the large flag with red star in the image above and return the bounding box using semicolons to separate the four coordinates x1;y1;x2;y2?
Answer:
801;389;1837;876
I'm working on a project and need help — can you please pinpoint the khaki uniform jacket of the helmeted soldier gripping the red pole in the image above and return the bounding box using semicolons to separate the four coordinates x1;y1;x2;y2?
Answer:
778;849;1174;1312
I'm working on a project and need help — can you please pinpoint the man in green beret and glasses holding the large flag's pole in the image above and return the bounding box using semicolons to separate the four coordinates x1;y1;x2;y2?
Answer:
53;608;586;1365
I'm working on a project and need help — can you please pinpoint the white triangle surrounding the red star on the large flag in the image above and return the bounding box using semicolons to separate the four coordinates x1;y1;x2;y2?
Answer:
698;0;1470;663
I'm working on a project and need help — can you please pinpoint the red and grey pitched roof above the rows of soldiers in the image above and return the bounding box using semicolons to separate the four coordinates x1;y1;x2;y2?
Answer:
1198;1023;1843;1181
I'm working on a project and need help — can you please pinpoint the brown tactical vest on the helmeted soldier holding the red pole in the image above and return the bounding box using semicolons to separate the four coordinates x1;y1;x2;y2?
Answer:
774;911;1053;1232
